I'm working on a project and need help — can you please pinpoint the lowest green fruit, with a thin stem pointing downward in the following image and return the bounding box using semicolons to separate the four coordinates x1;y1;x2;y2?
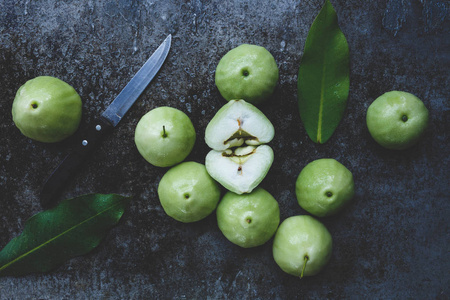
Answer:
273;215;332;277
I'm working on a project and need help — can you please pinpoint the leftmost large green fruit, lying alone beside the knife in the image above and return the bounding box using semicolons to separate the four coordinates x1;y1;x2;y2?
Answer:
12;76;82;143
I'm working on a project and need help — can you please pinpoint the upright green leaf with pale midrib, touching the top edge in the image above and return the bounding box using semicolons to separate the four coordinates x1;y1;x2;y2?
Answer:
297;0;350;144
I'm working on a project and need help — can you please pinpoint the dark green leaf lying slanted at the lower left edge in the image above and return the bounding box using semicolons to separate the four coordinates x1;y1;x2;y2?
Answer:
0;194;129;276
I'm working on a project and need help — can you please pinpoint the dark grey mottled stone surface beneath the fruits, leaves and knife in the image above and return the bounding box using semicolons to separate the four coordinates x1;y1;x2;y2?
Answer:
0;0;450;299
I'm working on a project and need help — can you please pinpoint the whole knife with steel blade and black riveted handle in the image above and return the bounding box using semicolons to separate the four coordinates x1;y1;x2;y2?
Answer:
40;34;172;208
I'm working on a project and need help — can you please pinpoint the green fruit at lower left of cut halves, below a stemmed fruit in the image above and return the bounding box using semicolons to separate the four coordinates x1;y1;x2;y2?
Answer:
158;162;220;223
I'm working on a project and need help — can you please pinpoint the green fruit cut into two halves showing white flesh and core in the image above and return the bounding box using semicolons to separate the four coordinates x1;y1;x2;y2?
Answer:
205;100;275;194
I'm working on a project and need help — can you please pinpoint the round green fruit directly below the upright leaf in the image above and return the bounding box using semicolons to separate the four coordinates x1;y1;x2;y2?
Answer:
295;158;355;217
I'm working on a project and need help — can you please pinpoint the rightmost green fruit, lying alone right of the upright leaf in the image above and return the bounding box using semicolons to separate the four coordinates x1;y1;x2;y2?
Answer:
366;91;428;150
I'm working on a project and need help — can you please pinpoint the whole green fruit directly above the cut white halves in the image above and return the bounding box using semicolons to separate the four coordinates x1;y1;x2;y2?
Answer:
215;44;278;104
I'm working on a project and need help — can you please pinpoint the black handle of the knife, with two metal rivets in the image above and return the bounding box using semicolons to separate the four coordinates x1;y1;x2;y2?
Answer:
40;118;113;208
